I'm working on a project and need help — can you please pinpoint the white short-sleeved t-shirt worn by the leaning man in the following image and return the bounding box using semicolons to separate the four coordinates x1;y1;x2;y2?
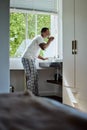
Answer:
23;35;44;58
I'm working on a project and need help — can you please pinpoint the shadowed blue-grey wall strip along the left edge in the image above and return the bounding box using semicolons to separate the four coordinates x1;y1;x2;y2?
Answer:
0;0;9;93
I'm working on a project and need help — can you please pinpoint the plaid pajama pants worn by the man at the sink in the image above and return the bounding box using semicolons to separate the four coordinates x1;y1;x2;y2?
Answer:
22;58;38;95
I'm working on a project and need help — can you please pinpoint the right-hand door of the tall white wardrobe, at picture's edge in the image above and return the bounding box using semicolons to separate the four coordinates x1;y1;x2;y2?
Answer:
75;0;87;109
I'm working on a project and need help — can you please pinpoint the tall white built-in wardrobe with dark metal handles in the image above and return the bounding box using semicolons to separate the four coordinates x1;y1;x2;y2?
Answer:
63;0;87;112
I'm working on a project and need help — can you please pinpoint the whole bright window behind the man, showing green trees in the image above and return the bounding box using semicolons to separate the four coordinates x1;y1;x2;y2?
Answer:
10;11;58;57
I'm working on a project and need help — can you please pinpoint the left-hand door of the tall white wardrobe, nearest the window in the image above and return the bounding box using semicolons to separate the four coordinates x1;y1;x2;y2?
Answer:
63;0;75;87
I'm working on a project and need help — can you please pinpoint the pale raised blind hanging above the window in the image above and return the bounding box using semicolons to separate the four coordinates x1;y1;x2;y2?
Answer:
10;0;58;13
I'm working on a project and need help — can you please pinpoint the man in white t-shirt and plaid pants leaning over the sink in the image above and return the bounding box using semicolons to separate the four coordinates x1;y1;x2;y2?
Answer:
22;27;54;95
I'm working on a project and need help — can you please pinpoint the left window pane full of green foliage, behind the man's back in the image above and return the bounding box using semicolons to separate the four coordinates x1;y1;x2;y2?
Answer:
10;13;26;57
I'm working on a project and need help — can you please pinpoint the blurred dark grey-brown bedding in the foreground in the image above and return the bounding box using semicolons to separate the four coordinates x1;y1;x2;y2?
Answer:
0;91;87;130
